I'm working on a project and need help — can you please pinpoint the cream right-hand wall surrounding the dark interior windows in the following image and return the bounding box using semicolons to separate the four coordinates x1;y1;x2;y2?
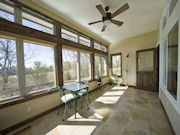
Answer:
159;0;180;135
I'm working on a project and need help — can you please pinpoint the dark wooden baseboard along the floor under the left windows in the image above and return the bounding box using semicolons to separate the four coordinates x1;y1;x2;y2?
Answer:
0;83;109;135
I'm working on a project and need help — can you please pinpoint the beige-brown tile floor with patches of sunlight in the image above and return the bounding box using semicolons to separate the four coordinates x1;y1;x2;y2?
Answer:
9;85;172;135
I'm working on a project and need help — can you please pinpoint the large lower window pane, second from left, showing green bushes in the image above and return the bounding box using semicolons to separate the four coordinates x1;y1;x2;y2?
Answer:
24;42;55;92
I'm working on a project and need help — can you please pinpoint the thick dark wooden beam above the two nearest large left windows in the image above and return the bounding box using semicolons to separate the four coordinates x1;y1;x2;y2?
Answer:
0;18;57;44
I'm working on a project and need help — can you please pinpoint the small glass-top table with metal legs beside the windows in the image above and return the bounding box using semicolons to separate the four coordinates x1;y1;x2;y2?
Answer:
62;83;89;119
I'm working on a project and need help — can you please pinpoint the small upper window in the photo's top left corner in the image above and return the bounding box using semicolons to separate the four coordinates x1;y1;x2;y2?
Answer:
0;2;14;22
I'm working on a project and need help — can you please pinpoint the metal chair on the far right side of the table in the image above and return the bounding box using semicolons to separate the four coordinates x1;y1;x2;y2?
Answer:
77;81;90;109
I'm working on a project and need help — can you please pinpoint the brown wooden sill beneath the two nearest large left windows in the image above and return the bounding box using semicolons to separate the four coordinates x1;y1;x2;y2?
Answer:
0;88;58;109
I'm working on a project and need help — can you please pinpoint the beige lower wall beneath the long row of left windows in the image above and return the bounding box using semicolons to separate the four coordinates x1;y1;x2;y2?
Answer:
0;77;109;130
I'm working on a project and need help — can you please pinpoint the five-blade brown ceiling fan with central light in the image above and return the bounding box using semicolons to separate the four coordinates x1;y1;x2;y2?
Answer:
88;3;129;32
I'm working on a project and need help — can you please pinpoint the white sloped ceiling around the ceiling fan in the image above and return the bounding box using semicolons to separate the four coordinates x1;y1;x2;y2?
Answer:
33;0;166;43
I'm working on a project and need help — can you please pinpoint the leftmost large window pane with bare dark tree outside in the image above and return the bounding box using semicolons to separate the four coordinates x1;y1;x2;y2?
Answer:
0;38;20;100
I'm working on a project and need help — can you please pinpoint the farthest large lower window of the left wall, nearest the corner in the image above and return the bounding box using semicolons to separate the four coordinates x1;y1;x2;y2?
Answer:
95;55;107;78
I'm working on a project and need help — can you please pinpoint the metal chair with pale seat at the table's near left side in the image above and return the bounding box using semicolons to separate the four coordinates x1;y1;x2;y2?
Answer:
59;87;77;121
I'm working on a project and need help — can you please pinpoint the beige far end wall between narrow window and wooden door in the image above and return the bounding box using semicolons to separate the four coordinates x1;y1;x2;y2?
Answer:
110;31;157;86
